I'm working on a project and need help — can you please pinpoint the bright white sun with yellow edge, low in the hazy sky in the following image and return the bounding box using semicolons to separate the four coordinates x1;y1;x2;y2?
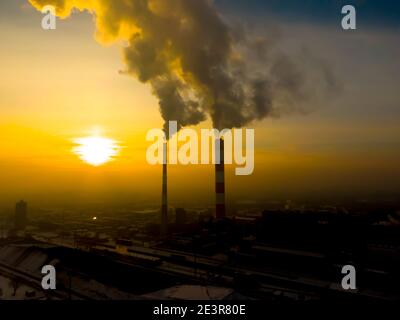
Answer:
73;136;121;167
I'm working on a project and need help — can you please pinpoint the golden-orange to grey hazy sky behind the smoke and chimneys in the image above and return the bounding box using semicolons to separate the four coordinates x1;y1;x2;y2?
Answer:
0;0;400;207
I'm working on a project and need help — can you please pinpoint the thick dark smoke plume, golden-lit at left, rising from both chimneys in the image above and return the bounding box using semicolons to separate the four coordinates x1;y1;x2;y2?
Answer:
29;0;335;129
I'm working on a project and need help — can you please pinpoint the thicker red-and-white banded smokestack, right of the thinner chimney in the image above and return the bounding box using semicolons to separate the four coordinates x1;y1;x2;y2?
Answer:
215;138;225;219
